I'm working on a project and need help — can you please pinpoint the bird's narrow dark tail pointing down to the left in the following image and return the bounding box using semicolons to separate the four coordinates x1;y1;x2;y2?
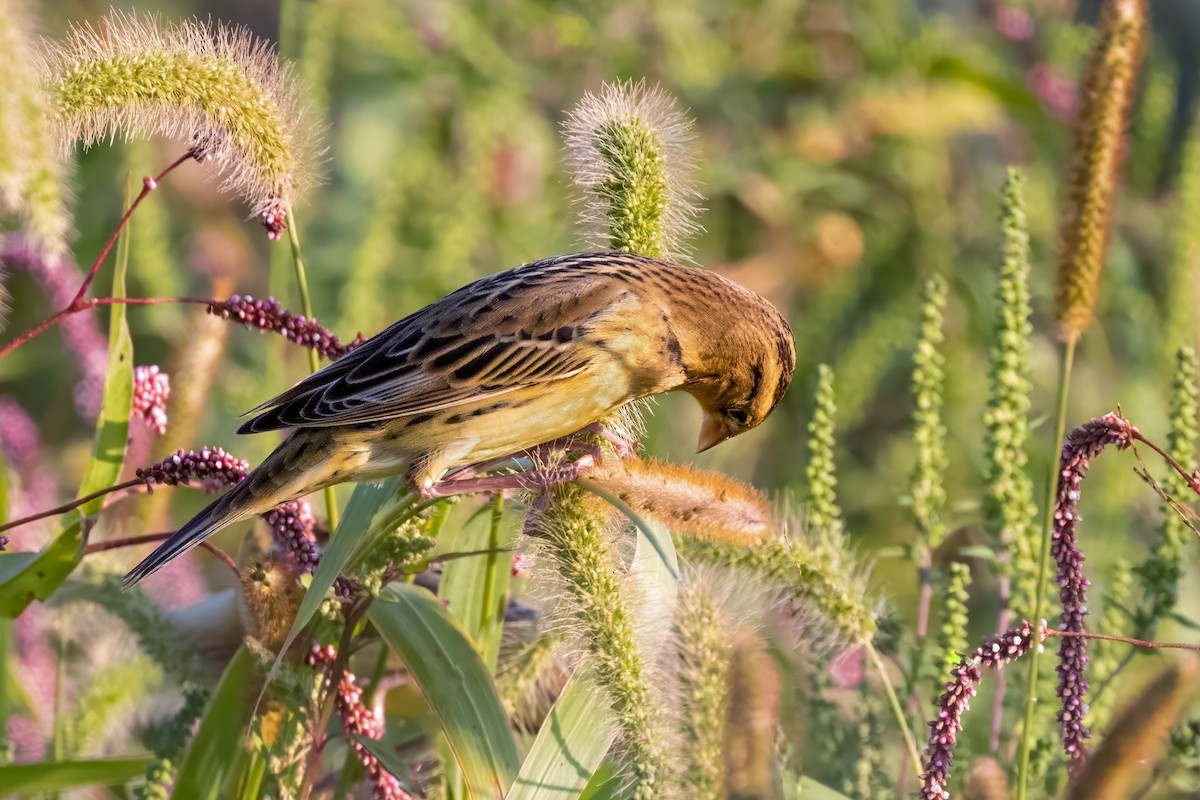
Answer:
125;428;346;588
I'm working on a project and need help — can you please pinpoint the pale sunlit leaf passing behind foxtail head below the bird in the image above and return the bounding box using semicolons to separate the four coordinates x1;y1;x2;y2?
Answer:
505;510;679;800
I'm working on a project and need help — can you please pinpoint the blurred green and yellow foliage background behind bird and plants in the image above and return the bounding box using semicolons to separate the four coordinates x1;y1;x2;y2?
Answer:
7;0;1200;786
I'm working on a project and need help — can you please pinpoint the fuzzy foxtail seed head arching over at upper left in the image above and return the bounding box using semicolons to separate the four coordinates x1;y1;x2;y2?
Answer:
40;11;320;237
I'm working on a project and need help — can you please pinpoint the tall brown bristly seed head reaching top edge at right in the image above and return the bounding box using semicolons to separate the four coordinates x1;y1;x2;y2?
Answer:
1055;0;1147;342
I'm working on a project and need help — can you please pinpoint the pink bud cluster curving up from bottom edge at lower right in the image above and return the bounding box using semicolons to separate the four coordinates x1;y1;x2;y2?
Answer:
918;621;1045;800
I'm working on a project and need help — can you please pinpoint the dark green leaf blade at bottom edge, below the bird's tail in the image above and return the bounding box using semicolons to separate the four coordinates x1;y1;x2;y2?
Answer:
173;646;259;800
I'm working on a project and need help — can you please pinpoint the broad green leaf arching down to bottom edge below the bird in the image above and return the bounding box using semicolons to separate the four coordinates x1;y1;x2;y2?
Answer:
367;583;521;800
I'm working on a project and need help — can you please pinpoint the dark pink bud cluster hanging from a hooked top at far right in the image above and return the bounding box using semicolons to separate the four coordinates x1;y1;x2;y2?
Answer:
1050;414;1138;760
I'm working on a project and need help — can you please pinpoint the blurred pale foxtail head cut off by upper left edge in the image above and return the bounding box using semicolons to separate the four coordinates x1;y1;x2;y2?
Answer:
0;0;71;255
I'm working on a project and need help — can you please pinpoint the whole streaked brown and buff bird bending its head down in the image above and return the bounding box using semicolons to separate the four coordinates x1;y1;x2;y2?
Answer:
125;252;796;585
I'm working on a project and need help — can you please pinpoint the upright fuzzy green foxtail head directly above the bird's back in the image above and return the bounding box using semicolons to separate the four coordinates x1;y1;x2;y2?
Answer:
564;82;700;258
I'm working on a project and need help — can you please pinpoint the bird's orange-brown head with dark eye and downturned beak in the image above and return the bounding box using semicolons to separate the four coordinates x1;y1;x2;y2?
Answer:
684;301;796;452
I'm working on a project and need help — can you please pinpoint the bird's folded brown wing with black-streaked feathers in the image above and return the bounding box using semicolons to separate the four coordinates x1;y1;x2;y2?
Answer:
238;255;635;433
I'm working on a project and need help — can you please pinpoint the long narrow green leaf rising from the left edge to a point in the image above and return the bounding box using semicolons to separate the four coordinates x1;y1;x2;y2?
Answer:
0;200;133;619
